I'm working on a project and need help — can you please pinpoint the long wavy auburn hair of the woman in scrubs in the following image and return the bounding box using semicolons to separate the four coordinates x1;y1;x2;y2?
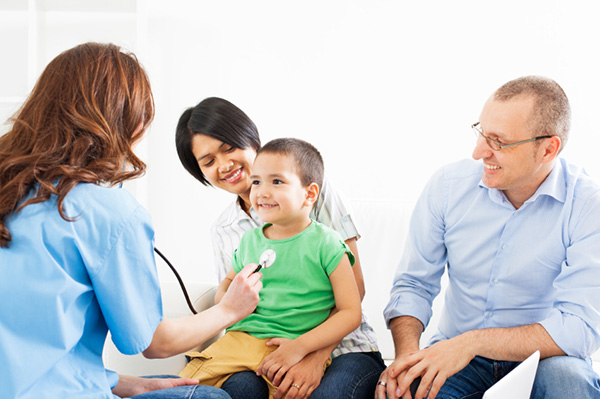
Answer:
0;43;154;248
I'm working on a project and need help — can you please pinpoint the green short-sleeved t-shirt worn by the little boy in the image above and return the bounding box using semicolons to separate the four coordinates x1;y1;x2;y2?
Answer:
228;220;354;339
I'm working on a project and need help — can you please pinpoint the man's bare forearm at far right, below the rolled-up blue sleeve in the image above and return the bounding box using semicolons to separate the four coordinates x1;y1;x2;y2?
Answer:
456;323;565;362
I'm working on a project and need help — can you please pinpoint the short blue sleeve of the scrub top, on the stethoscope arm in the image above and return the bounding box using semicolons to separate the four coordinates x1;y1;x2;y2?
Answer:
85;205;162;354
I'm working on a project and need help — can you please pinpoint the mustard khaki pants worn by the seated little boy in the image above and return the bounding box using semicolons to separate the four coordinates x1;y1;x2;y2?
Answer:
179;331;331;398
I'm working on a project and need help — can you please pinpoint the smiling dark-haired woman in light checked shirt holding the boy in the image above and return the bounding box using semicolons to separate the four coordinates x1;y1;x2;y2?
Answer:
175;97;385;399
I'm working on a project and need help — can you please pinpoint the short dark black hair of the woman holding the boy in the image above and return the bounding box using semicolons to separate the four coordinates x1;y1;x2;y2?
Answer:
175;97;260;186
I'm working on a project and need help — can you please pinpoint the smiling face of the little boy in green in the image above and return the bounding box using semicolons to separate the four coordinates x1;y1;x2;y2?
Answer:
250;153;318;229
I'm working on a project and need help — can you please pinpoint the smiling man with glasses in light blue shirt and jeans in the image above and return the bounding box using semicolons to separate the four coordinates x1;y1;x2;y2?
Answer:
375;76;600;399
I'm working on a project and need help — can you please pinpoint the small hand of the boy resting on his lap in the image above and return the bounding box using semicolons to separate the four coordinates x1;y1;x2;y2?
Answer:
256;338;306;386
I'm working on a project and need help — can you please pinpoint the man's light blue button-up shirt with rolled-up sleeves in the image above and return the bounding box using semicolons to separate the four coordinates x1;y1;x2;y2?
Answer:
384;159;600;358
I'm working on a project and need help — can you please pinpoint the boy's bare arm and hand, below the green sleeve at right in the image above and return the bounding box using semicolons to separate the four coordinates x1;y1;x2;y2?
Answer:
258;256;362;382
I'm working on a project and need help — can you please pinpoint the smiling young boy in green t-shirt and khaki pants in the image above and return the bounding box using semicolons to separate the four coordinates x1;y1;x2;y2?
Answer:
180;139;361;397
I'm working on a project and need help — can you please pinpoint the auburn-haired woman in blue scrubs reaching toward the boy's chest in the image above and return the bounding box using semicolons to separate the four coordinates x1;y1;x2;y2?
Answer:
0;43;261;399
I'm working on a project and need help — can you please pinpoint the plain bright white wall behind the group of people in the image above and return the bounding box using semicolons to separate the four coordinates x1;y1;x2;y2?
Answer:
0;0;600;289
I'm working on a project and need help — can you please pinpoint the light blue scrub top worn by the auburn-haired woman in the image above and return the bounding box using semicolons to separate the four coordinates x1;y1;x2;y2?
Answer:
0;184;162;399
